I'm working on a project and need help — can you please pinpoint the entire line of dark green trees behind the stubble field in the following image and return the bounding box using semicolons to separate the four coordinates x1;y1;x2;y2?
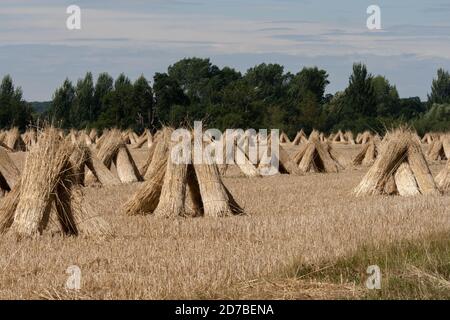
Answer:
0;58;450;135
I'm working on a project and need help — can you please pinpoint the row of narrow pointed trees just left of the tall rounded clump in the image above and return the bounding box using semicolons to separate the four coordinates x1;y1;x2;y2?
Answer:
46;72;154;130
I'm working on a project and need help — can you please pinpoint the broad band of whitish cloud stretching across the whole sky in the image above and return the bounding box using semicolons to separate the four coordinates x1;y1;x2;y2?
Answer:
0;5;450;58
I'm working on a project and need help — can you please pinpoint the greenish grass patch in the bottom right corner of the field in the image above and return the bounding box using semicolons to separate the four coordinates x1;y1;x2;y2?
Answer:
289;234;450;299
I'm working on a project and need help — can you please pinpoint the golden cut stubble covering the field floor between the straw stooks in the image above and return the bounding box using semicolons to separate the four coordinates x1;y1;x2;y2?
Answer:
0;145;450;299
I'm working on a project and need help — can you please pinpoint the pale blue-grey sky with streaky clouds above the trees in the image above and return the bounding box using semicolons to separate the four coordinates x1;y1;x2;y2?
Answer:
0;0;450;101
